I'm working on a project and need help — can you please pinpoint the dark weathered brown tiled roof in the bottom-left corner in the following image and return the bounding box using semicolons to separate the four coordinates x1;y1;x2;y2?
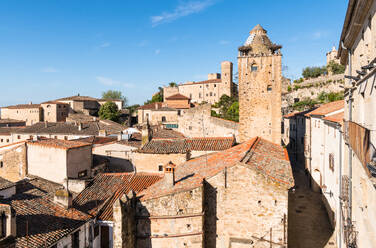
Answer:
0;178;89;248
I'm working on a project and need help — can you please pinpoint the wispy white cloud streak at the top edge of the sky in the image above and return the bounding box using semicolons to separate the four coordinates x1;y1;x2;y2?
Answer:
151;0;215;27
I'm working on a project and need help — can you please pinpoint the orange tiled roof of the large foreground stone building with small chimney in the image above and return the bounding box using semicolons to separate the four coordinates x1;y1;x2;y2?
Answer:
138;137;293;200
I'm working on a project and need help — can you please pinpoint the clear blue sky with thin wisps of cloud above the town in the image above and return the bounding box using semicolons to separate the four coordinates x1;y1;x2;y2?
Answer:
0;0;348;106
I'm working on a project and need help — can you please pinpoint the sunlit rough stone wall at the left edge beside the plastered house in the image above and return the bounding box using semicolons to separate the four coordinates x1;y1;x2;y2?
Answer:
0;143;27;182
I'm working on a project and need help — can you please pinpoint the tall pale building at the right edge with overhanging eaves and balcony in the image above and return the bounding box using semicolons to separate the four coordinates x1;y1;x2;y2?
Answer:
338;0;376;247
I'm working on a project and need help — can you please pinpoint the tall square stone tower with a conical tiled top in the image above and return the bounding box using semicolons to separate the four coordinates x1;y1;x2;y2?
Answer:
238;25;282;144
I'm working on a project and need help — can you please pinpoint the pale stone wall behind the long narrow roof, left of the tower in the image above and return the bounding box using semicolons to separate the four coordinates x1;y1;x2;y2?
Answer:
178;104;239;141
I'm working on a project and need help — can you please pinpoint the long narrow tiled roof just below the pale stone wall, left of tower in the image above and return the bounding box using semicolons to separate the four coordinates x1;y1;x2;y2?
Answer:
138;137;235;154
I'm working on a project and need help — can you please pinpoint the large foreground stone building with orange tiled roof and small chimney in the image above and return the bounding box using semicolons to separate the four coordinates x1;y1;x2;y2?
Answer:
113;138;294;248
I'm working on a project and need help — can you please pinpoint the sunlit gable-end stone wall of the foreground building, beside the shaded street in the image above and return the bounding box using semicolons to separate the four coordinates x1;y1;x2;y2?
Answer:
204;165;288;248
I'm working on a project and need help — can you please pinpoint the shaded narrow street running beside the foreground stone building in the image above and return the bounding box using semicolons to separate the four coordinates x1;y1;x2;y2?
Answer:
288;170;337;248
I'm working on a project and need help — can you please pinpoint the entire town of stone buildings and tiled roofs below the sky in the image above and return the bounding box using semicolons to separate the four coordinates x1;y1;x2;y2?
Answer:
0;0;376;248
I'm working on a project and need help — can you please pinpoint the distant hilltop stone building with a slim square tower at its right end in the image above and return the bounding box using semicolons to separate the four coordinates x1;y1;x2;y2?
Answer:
163;61;237;104
